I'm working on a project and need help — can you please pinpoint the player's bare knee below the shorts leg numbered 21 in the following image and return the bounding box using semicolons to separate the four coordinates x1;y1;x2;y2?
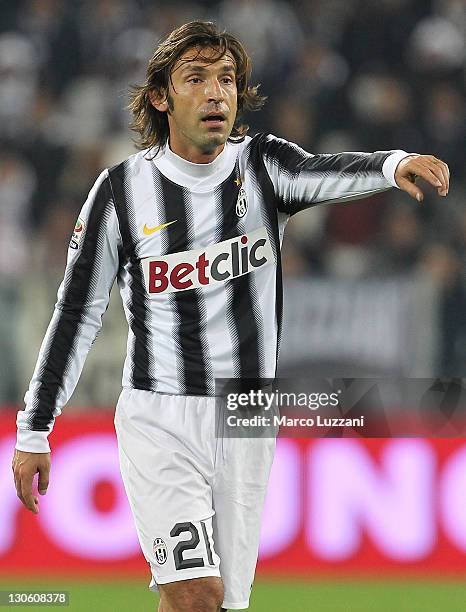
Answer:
159;576;223;612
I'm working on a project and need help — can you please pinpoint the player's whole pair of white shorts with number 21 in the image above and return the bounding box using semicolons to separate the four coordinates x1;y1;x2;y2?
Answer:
115;389;275;610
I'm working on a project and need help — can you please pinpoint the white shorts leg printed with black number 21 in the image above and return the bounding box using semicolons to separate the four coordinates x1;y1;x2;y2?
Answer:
115;391;220;590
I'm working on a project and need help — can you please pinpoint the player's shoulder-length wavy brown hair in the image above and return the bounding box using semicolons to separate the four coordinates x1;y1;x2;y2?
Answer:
128;21;266;153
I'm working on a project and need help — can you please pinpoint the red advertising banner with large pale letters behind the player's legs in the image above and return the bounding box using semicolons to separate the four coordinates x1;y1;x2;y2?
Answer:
0;410;466;578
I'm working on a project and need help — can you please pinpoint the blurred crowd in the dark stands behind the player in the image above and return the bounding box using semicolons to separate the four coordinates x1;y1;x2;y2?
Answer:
0;0;466;404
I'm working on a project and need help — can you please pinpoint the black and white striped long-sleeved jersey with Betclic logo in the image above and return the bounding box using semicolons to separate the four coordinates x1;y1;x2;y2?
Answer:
17;134;408;452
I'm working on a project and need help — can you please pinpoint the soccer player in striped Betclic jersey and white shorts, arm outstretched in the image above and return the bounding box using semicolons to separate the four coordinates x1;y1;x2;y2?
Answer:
13;22;449;612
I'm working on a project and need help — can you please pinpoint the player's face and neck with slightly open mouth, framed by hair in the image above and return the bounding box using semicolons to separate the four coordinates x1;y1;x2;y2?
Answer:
154;48;237;159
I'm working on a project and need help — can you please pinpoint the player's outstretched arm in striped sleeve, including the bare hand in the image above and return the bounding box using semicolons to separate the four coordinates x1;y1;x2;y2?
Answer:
263;135;449;215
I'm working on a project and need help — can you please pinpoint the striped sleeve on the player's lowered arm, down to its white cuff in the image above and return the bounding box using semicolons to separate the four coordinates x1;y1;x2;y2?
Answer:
16;170;121;453
